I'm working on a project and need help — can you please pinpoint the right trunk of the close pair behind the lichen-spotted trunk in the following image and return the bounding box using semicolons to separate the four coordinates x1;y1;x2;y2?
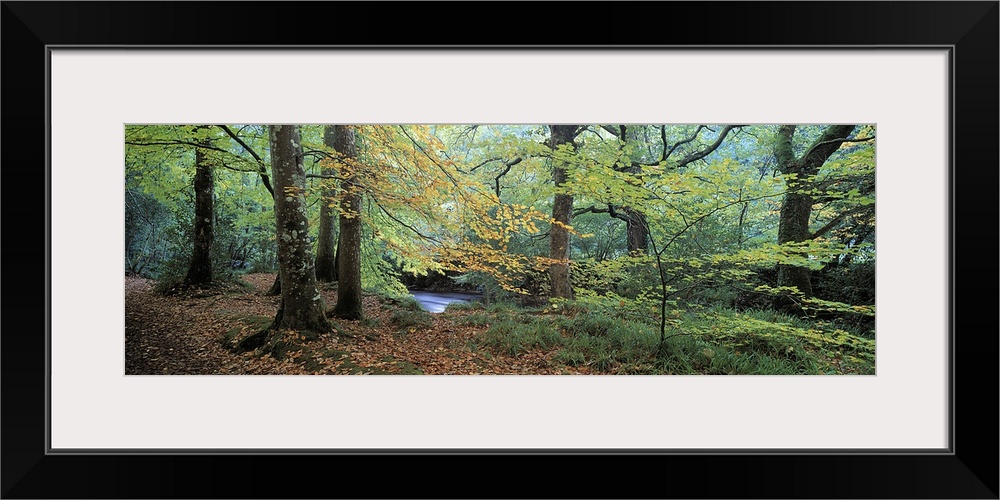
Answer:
333;125;363;319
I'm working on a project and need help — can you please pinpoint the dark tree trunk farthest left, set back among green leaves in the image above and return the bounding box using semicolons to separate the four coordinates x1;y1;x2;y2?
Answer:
184;141;215;286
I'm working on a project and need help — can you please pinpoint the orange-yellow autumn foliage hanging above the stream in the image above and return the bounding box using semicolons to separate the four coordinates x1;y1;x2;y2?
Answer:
339;125;552;295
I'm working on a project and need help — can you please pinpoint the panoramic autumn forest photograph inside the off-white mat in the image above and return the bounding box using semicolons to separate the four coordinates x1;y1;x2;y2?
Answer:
124;124;876;375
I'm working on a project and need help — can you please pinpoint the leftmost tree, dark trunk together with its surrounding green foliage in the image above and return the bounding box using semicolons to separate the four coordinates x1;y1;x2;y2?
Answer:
125;125;286;291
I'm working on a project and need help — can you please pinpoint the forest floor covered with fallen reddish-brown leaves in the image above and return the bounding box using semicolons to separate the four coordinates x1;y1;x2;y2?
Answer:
125;274;591;375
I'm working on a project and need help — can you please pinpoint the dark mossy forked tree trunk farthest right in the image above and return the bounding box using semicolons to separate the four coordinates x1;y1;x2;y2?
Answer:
775;125;855;297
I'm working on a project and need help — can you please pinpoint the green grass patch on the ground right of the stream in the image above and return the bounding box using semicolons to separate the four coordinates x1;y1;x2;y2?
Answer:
459;296;875;375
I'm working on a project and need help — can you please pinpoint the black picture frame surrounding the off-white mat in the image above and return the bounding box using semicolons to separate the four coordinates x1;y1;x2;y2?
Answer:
0;1;1000;498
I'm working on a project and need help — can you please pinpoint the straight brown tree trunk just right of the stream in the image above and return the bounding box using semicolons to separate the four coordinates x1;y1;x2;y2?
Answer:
549;125;578;299
